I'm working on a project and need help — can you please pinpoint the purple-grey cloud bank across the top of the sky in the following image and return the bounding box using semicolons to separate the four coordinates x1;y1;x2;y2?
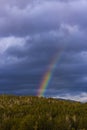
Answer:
0;0;87;36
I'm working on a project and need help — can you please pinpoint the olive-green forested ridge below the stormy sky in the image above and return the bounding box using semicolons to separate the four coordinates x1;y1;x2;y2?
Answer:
0;95;87;130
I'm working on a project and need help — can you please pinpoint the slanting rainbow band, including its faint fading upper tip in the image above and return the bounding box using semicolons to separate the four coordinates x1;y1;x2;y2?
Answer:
37;43;69;97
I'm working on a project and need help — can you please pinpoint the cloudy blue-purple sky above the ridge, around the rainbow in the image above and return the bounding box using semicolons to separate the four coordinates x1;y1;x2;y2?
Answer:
0;0;87;101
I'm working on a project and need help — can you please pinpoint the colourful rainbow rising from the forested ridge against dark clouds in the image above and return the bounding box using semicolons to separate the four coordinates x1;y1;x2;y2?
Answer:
37;52;62;97
